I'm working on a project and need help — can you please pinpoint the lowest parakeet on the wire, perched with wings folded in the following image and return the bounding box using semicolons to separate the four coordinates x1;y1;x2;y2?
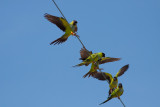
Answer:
99;83;124;105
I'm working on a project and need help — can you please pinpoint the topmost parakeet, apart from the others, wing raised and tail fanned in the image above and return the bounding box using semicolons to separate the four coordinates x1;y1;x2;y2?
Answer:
44;13;78;45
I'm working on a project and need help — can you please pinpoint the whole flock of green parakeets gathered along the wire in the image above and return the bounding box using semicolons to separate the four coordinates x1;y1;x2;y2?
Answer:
44;13;129;104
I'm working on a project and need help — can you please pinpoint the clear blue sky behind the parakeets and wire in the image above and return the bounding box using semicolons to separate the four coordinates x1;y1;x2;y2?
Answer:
0;0;160;107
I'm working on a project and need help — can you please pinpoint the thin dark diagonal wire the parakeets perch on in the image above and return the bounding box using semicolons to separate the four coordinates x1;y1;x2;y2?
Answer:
52;0;125;107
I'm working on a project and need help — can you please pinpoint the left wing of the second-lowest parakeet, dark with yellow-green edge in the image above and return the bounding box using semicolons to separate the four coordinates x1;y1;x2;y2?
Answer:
93;72;112;83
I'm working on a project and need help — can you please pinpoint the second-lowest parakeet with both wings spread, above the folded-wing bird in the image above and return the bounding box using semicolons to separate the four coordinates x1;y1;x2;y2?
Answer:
93;64;129;95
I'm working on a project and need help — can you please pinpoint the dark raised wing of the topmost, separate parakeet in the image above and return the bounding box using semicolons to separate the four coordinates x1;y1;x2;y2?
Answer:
44;13;68;31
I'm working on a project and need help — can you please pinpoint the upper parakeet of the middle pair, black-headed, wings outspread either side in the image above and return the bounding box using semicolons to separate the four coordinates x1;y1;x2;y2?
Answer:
76;48;120;66
